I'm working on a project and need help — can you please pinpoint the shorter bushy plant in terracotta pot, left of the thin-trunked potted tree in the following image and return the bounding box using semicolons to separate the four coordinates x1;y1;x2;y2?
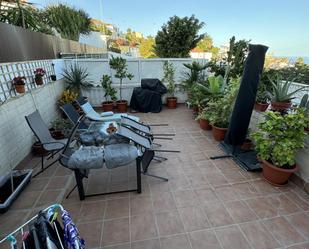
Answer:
101;75;117;112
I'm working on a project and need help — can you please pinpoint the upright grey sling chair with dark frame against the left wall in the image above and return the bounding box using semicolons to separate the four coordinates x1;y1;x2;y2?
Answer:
25;111;67;177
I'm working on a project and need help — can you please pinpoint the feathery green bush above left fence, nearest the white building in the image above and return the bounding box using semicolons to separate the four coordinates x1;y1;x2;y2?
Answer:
44;4;91;41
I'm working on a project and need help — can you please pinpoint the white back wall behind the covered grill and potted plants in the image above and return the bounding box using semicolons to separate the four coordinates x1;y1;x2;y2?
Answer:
65;58;207;106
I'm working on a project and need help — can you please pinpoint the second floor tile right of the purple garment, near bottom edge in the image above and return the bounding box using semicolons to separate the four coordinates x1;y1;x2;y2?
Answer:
102;218;130;246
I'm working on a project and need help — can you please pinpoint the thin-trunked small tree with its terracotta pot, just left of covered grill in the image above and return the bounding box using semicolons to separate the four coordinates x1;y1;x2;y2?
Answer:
109;56;134;112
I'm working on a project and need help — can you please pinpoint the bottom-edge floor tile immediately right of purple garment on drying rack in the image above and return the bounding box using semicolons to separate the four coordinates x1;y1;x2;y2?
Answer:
78;222;102;248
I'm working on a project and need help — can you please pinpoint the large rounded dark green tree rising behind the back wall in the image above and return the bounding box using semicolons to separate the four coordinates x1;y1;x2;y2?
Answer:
155;15;204;58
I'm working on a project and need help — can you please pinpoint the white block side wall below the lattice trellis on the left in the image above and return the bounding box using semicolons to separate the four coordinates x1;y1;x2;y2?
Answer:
0;80;64;175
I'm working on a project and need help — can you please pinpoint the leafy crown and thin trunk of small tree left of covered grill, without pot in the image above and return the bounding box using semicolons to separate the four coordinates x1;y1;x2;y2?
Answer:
109;56;134;101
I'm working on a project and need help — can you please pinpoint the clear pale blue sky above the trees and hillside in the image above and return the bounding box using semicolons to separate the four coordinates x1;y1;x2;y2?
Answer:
29;0;309;57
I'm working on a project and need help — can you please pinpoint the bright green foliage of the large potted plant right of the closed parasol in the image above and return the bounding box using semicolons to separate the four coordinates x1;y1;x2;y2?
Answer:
251;108;308;168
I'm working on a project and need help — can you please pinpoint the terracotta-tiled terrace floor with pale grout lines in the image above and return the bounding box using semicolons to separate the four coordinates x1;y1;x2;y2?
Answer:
0;106;309;249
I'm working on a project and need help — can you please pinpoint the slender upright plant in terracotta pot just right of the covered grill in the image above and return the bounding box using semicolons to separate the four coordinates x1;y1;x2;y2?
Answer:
162;61;177;109
